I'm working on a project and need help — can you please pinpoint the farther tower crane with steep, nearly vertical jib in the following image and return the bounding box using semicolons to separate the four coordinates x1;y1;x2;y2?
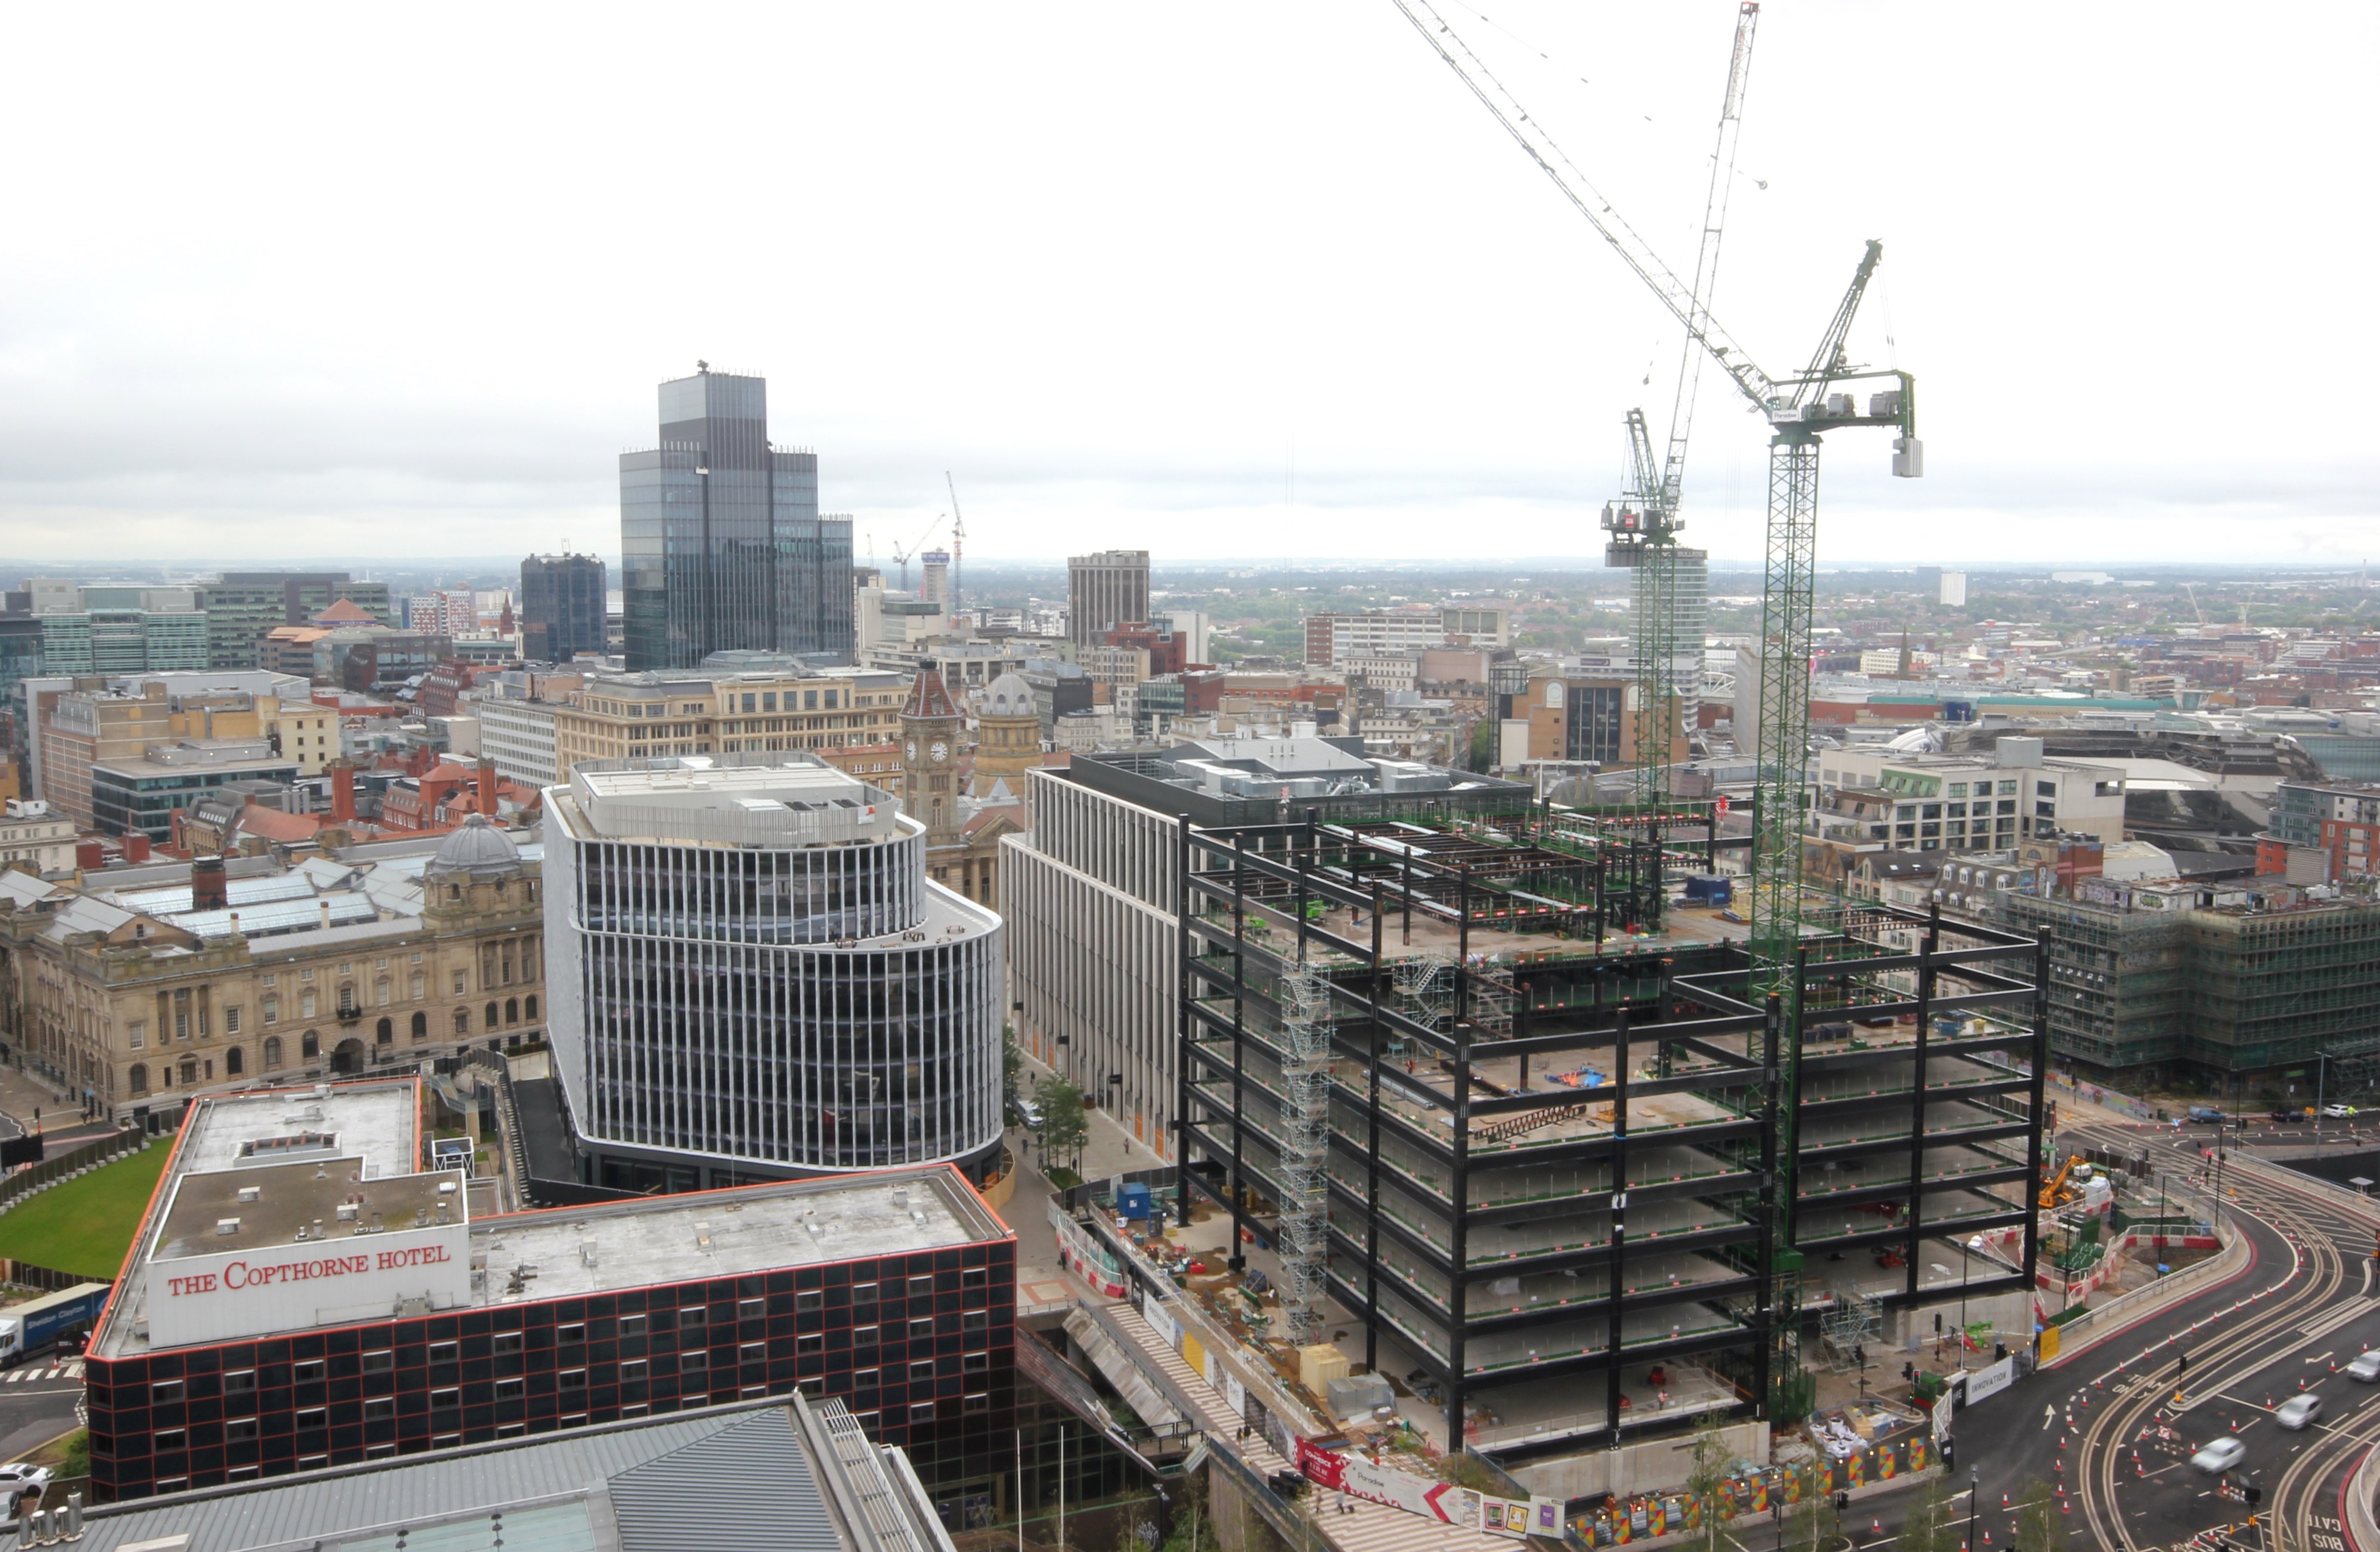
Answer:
1604;0;1761;931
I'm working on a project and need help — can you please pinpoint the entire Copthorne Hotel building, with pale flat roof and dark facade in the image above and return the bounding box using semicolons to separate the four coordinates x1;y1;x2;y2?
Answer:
86;1078;1016;1502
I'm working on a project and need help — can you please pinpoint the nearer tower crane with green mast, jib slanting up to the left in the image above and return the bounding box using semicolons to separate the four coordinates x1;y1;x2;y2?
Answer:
1390;0;1926;1400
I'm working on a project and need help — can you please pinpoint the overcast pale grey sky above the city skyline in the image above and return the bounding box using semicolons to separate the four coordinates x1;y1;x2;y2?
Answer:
0;0;2380;562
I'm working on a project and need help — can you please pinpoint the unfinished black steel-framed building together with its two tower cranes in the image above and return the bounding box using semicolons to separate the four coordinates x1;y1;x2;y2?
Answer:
1140;0;2049;1502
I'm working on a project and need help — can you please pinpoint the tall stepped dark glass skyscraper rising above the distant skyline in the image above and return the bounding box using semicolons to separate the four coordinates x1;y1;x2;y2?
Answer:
619;364;852;669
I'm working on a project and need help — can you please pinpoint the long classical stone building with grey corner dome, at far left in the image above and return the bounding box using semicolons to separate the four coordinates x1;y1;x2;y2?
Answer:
0;814;545;1121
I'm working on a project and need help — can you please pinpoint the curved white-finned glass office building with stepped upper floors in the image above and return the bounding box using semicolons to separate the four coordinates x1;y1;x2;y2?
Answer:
545;755;1002;1190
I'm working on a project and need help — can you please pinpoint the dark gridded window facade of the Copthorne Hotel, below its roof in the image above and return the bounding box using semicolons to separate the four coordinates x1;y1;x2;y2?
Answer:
88;1183;1016;1502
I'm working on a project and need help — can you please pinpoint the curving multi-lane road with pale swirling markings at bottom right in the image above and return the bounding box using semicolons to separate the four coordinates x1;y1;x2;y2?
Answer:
1956;1126;2380;1552
